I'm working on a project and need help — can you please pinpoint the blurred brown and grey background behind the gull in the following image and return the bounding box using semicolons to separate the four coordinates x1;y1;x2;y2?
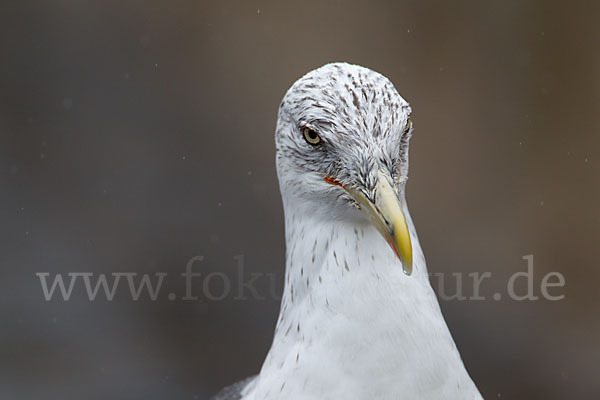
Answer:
0;0;600;400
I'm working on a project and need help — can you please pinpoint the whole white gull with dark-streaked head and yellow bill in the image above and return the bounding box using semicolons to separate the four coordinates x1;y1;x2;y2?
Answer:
214;63;482;400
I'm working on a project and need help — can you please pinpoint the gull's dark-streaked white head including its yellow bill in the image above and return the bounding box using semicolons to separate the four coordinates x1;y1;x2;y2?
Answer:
275;63;412;274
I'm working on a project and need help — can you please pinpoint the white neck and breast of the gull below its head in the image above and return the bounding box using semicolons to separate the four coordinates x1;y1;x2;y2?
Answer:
244;200;481;400
